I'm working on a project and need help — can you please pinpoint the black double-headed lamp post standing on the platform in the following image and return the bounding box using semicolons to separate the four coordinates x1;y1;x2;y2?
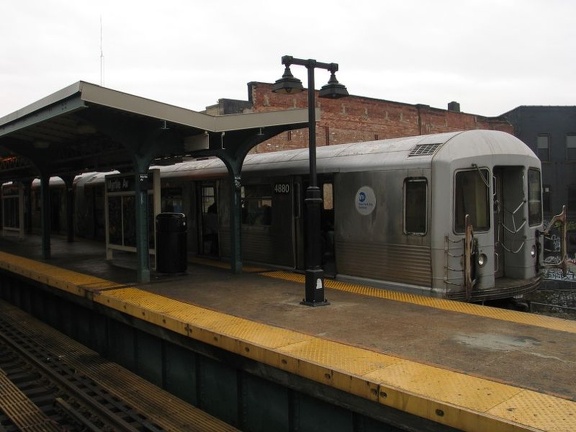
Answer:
272;56;348;306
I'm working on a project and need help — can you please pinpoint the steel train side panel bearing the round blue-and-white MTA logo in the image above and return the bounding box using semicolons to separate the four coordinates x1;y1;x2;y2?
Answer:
334;168;431;292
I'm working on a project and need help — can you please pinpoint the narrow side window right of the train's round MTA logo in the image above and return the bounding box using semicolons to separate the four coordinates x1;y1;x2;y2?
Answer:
404;178;428;235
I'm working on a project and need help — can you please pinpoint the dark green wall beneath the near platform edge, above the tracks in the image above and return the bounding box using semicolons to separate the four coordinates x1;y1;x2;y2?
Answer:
0;260;452;432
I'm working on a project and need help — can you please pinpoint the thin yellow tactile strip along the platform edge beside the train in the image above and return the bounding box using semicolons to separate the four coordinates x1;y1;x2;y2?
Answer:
262;271;576;333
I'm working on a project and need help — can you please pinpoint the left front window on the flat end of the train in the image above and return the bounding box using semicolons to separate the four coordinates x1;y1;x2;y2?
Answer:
454;169;490;233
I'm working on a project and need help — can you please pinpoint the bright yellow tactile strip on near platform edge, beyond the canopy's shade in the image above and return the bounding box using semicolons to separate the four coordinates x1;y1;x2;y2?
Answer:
99;288;576;432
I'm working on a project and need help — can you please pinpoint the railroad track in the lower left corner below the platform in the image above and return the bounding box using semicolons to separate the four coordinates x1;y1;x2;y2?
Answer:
0;302;236;432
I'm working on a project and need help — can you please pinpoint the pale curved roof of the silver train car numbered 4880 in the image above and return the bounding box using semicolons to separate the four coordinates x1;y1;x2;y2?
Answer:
153;130;536;178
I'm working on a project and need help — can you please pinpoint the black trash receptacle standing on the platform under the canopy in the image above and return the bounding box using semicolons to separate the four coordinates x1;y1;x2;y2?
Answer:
156;213;188;273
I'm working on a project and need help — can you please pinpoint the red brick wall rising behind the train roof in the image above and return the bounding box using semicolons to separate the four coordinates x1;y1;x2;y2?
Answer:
248;82;514;152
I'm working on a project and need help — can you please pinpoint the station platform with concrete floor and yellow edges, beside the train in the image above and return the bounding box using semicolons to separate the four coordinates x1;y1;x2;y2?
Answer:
0;237;576;431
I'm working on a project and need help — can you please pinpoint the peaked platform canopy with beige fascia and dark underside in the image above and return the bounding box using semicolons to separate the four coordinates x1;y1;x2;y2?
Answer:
0;81;307;182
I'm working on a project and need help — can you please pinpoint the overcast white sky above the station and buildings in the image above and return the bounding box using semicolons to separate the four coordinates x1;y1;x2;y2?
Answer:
0;0;576;117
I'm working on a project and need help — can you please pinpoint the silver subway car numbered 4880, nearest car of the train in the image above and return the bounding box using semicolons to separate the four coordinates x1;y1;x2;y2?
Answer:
156;130;543;302
